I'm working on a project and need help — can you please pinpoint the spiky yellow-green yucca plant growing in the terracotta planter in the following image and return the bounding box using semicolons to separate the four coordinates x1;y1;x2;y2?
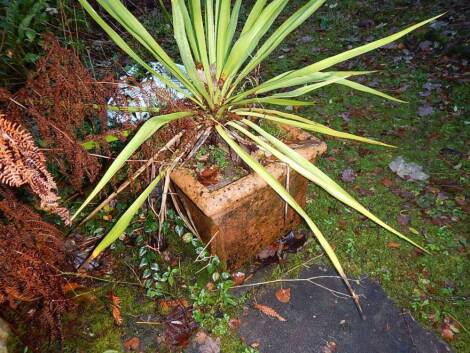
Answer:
73;0;439;311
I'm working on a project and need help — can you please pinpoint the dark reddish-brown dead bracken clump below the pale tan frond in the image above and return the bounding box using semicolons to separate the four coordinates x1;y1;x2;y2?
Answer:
0;192;72;344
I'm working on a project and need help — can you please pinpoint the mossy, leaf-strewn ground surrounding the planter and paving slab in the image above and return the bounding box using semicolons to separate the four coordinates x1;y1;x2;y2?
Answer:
5;0;470;353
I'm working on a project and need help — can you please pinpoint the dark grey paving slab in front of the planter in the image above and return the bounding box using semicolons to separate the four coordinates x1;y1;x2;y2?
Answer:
239;266;452;353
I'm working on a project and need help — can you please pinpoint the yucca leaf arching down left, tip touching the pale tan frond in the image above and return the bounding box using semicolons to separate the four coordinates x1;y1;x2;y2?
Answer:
72;112;193;220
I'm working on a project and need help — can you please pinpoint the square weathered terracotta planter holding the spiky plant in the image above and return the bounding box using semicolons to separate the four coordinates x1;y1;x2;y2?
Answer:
171;129;326;269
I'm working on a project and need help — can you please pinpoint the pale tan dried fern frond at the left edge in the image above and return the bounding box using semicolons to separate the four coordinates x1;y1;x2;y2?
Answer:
0;114;69;224
